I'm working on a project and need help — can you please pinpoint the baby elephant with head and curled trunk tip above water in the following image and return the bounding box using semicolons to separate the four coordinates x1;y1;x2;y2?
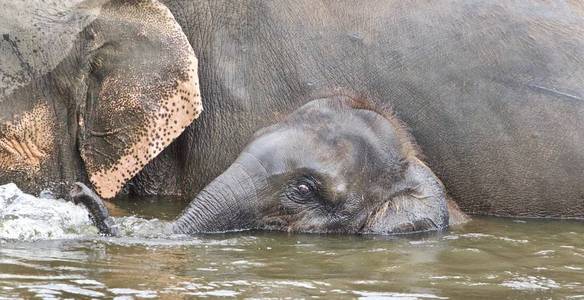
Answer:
71;96;463;235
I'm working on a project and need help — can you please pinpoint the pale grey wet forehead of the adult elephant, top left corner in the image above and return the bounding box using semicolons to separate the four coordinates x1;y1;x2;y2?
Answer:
0;0;107;96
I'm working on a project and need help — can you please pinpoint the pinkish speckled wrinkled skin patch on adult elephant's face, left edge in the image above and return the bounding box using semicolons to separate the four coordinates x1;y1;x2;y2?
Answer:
0;104;54;174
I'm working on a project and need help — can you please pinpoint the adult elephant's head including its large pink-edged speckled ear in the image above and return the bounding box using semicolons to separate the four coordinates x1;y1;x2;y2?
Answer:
0;0;202;198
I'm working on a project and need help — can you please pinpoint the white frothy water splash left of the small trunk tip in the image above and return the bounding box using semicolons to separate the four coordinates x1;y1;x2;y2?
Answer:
0;183;98;241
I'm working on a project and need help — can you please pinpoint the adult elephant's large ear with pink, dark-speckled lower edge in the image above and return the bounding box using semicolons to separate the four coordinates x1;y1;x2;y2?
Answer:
78;0;202;198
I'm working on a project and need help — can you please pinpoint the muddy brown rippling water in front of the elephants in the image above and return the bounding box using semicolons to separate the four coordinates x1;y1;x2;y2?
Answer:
0;184;584;299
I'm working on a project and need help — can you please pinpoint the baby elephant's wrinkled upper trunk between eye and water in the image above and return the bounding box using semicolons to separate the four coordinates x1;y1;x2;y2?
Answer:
172;157;264;234
